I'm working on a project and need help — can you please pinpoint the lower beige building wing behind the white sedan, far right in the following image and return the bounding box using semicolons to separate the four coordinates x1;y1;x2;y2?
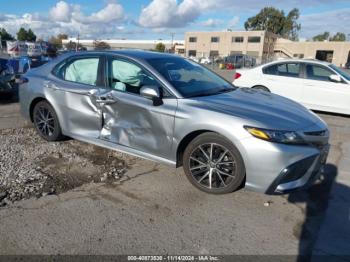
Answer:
274;38;350;67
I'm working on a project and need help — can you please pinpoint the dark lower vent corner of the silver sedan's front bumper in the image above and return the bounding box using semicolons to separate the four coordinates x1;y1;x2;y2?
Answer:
265;144;329;194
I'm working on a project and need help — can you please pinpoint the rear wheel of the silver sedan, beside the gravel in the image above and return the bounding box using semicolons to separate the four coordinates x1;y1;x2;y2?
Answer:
33;101;64;142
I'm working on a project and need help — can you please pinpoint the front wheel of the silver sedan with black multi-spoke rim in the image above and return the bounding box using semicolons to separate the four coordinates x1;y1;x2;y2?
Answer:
183;132;245;194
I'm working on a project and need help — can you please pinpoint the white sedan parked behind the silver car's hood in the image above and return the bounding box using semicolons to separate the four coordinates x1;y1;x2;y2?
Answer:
233;59;350;115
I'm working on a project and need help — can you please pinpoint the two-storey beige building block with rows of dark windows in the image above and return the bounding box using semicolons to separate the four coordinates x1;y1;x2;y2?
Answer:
185;31;277;62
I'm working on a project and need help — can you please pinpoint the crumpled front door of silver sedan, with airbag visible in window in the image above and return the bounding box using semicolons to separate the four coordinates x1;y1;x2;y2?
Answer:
101;56;177;158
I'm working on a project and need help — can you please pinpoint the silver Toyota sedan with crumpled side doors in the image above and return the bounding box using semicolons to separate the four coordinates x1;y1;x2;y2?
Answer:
20;50;329;194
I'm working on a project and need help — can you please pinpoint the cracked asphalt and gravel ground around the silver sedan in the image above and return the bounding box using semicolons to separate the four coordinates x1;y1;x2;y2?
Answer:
0;87;350;256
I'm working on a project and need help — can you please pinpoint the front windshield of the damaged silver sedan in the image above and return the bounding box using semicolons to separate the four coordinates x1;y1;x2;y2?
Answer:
147;57;236;97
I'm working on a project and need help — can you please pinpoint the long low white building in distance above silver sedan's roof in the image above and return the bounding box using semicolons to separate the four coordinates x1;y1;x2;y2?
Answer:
62;38;184;50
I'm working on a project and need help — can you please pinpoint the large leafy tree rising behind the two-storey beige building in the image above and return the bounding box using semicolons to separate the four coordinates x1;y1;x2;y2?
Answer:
244;7;301;40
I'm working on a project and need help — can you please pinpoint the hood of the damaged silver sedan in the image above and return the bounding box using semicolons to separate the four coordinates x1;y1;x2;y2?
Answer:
189;88;325;131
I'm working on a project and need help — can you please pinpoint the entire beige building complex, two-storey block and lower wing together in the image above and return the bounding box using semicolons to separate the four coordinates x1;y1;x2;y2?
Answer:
185;31;350;66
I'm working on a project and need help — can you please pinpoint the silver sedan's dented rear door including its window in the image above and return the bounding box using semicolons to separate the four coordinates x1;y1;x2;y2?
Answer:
50;55;103;138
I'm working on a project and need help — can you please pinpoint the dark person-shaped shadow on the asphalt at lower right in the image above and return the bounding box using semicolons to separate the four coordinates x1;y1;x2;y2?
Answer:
288;164;350;262
